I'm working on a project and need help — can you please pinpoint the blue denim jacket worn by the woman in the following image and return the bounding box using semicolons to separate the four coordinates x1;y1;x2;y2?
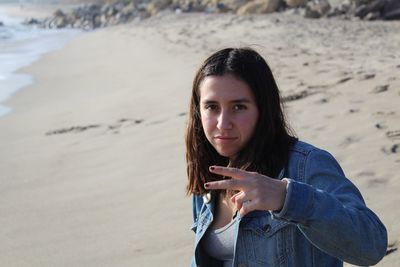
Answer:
191;141;387;267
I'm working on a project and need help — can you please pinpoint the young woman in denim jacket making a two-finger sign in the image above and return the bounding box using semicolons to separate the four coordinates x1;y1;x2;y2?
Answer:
186;48;387;267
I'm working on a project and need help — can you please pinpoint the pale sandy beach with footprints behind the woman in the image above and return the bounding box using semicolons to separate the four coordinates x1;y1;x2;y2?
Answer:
0;3;400;266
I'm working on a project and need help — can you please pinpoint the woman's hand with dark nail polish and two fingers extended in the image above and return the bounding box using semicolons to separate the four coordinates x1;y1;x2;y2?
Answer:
204;166;287;217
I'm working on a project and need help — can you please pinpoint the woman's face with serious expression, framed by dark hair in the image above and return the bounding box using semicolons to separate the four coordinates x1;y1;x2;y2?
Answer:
199;74;258;159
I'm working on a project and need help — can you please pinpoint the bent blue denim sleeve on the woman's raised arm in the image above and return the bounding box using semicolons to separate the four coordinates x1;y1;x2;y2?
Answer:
273;149;387;265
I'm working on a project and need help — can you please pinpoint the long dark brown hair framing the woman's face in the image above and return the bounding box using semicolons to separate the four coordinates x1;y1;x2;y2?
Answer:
186;48;296;195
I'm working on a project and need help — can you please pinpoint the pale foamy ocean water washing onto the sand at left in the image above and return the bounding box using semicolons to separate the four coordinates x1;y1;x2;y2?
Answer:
0;6;80;116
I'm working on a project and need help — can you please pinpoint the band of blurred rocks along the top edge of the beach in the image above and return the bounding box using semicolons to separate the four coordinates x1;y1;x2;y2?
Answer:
21;0;400;30
